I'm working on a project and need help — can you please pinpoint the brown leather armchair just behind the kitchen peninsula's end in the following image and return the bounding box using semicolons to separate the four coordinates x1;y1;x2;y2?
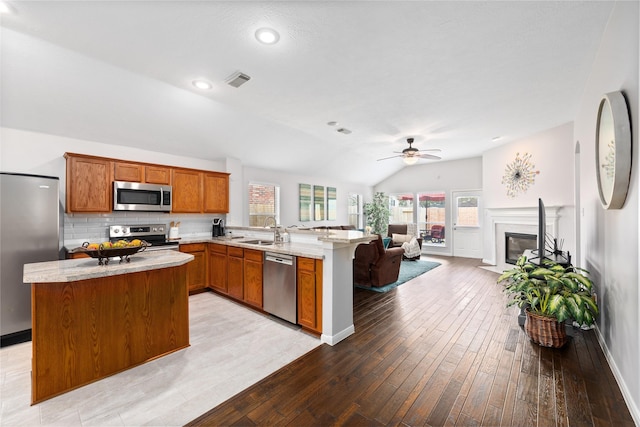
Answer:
353;235;404;287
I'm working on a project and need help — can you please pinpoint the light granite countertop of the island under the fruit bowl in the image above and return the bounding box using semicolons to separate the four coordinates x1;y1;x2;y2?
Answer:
22;250;194;284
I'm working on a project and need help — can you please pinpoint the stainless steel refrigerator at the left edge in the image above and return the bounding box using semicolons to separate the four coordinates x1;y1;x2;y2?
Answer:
0;172;61;347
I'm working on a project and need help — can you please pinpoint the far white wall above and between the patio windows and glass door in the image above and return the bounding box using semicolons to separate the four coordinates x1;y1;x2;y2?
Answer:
374;157;482;255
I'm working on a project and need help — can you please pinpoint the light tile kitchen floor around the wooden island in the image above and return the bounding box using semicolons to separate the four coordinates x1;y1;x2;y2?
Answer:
0;292;320;426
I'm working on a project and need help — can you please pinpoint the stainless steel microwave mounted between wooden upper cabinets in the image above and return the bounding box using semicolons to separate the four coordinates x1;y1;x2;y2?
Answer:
113;181;171;212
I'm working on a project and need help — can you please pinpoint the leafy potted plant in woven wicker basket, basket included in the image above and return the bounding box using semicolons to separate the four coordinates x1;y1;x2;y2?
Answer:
498;256;598;348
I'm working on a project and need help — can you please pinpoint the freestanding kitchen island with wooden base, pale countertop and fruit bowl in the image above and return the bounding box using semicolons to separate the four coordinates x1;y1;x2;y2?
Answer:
23;250;193;404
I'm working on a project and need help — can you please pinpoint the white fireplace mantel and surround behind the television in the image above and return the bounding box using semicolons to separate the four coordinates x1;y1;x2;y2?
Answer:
483;206;562;269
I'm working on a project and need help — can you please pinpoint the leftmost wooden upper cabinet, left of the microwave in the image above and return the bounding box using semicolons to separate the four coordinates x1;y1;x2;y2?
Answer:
64;153;113;213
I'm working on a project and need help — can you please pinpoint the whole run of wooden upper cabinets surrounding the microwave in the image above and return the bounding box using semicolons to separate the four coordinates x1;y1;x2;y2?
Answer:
64;153;229;213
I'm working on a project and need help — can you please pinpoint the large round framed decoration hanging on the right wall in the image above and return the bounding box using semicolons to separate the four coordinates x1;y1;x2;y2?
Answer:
596;92;631;209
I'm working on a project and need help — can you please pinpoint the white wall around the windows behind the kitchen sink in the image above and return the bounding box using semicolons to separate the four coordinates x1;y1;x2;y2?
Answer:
242;167;372;227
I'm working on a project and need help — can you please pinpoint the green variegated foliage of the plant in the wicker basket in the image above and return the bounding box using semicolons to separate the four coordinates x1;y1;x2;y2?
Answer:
498;256;598;326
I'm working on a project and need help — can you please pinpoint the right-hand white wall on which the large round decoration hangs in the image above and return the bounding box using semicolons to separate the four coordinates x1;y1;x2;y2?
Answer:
574;2;640;425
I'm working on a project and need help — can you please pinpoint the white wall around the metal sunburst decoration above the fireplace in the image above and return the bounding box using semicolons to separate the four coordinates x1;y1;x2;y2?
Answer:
482;123;575;255
